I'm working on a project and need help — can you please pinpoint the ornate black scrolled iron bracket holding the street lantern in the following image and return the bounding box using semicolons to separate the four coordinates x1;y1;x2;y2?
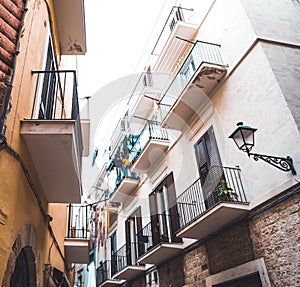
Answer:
247;151;297;175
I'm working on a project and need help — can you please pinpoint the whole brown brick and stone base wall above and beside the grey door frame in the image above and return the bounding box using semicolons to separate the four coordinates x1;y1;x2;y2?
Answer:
183;191;300;287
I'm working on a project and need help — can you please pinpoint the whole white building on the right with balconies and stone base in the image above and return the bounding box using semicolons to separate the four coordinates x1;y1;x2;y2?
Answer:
96;0;300;287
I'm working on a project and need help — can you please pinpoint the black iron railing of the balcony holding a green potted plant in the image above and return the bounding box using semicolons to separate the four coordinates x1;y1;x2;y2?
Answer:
176;166;247;228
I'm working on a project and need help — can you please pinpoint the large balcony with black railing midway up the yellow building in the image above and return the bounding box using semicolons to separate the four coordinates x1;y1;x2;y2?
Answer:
20;71;83;203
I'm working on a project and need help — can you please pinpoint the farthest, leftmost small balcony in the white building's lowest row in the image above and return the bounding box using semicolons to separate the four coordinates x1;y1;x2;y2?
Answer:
96;260;125;287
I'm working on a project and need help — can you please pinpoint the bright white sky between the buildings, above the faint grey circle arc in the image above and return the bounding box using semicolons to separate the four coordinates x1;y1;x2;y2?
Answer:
78;0;167;98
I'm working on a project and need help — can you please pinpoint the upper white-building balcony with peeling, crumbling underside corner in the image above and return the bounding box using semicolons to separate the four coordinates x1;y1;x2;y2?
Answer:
160;41;227;131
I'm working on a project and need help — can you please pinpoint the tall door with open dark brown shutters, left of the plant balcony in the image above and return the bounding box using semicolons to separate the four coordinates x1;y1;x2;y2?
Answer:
149;173;181;246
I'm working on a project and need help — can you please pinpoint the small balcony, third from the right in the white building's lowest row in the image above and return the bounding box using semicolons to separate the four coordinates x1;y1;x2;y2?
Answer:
111;243;146;281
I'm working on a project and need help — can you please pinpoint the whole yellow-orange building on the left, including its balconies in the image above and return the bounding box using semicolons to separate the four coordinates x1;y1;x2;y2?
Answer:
0;0;90;287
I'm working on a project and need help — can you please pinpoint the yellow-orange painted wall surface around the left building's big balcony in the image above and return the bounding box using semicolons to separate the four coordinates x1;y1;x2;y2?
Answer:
0;0;74;286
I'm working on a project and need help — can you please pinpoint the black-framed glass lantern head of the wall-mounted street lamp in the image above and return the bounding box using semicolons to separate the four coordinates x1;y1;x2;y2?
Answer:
229;123;257;152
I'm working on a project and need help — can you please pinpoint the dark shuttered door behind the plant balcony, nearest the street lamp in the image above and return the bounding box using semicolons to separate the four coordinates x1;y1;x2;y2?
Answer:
195;127;224;208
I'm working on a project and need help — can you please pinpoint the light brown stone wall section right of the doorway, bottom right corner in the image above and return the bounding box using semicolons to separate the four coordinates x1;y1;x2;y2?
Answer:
250;191;300;287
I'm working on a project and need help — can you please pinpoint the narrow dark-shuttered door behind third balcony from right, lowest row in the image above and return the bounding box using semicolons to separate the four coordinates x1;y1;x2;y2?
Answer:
125;207;143;265
